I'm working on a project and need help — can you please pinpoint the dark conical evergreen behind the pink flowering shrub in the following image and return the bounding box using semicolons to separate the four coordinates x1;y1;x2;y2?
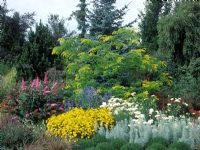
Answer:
17;21;54;79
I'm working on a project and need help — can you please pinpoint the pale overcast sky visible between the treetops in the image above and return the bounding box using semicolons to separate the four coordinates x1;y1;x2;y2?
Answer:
5;0;145;30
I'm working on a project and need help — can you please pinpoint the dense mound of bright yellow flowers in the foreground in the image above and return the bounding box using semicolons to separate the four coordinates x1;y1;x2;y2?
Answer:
47;108;114;139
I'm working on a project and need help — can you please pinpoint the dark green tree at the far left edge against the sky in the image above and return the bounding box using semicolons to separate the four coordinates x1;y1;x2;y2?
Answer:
0;1;34;62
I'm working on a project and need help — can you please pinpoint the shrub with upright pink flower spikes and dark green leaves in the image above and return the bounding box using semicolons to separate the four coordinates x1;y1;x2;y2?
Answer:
3;73;64;122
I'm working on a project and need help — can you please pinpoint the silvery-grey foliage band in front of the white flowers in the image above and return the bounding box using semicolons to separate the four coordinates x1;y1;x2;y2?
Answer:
98;116;200;149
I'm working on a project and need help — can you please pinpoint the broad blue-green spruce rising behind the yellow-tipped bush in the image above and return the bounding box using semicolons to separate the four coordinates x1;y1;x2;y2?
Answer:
88;0;128;37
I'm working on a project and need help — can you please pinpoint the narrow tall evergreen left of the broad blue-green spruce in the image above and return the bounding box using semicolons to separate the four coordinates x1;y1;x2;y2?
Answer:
70;0;88;38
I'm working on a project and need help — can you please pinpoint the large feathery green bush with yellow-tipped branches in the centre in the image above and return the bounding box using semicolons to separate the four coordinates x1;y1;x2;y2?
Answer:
52;29;171;100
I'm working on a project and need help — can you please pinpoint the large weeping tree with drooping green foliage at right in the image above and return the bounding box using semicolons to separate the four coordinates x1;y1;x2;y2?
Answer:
158;2;200;75
